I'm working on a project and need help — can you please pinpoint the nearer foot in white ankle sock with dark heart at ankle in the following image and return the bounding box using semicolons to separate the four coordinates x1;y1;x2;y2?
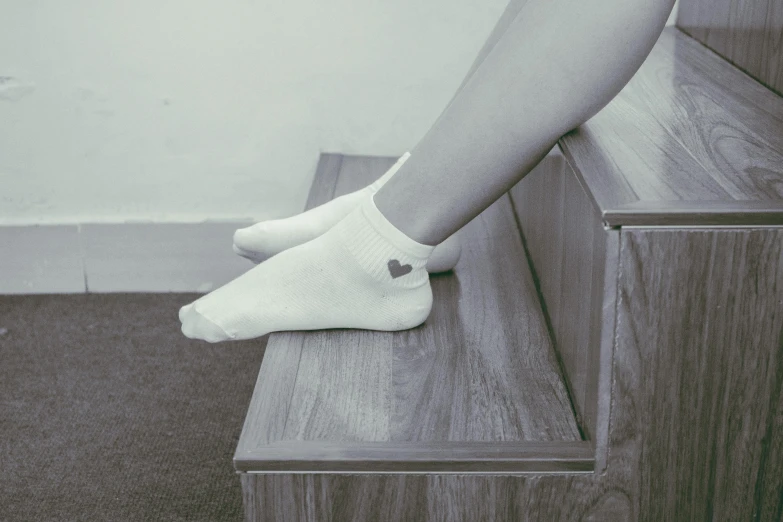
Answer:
179;196;435;343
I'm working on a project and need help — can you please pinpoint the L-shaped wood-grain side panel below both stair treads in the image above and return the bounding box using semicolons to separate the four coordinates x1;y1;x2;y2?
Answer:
242;228;783;522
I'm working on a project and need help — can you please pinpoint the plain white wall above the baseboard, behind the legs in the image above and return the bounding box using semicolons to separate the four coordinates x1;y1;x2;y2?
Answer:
0;0;680;224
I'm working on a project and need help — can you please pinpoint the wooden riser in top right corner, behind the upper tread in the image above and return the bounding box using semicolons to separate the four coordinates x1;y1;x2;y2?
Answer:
677;0;783;95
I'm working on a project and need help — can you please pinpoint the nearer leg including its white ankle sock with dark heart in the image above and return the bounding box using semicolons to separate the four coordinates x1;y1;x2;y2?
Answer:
180;0;674;342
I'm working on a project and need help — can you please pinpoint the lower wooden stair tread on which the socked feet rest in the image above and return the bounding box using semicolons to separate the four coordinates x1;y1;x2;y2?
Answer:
235;154;589;470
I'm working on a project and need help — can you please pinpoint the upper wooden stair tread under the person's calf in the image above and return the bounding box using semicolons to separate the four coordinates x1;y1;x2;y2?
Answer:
559;27;783;226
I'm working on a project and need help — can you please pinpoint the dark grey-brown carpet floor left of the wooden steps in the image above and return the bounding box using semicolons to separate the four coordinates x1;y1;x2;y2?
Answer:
0;294;266;522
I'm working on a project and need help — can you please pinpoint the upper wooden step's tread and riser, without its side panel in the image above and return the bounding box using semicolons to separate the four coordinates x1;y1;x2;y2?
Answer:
511;28;783;448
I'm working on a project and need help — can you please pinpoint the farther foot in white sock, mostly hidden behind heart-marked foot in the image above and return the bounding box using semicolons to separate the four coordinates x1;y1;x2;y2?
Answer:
233;152;462;273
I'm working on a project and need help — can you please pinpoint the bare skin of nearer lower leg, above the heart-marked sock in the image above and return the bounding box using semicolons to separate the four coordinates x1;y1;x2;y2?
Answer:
374;0;674;245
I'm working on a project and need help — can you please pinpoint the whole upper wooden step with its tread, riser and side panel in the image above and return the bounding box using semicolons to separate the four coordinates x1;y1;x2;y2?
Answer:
511;23;783;520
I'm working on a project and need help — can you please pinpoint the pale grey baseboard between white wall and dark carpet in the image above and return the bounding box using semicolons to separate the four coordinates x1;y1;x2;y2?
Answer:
0;221;254;294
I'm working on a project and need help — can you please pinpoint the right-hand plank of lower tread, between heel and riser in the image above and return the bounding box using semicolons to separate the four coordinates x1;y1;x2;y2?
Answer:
392;198;579;441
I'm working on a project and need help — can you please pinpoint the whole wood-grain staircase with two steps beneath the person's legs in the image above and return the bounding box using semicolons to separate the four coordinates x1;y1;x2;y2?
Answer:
234;8;783;521
